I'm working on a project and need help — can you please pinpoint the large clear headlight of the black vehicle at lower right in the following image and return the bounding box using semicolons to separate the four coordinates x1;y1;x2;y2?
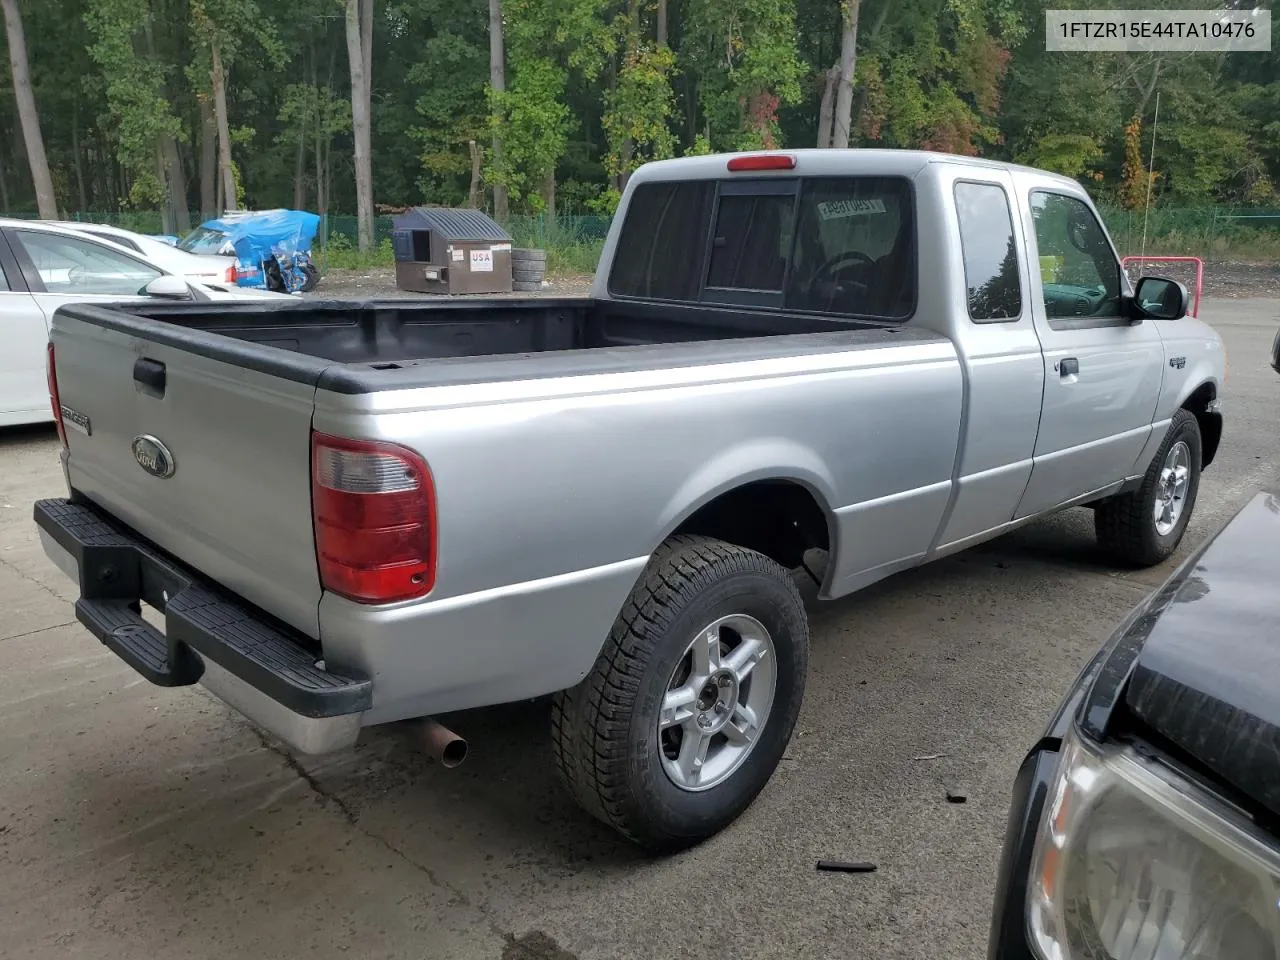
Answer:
1027;731;1280;960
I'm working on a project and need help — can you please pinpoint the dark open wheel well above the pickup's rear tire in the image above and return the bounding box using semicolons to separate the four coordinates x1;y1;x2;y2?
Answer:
672;480;831;570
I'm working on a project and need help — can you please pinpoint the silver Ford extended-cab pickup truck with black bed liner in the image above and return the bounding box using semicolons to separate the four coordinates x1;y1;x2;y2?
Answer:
35;150;1224;850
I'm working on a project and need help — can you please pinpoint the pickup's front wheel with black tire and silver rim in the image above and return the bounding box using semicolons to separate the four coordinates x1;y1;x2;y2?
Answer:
1093;410;1202;567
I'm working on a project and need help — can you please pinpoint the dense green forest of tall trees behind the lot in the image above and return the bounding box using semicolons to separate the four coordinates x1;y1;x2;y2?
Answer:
0;0;1280;256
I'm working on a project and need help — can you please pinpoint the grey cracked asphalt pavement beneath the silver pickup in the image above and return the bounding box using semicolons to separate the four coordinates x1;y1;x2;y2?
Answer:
0;300;1280;960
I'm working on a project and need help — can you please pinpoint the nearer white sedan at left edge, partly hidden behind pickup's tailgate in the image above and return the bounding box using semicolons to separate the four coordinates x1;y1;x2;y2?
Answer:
0;219;292;426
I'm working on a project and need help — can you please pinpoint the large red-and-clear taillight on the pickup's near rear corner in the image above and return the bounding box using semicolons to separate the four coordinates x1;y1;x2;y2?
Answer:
311;434;435;603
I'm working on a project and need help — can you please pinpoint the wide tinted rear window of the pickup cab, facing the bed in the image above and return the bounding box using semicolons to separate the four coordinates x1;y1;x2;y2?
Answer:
609;177;916;320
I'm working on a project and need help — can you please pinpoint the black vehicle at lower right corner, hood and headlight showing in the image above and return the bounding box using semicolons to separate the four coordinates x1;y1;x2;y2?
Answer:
989;491;1280;960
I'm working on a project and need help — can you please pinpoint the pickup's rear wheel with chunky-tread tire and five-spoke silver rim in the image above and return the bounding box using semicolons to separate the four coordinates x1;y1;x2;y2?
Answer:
552;536;809;852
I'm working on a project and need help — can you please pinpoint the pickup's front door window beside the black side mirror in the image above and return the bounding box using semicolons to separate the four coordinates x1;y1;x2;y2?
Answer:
1032;191;1123;320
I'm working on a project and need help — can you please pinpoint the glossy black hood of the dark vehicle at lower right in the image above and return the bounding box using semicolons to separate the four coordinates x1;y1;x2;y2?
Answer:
1124;493;1280;815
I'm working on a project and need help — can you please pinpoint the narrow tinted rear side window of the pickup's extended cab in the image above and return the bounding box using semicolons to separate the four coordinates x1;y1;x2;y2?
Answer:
955;183;1023;323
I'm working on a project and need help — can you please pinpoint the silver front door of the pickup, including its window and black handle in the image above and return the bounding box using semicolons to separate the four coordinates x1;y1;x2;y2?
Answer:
1015;187;1164;517
